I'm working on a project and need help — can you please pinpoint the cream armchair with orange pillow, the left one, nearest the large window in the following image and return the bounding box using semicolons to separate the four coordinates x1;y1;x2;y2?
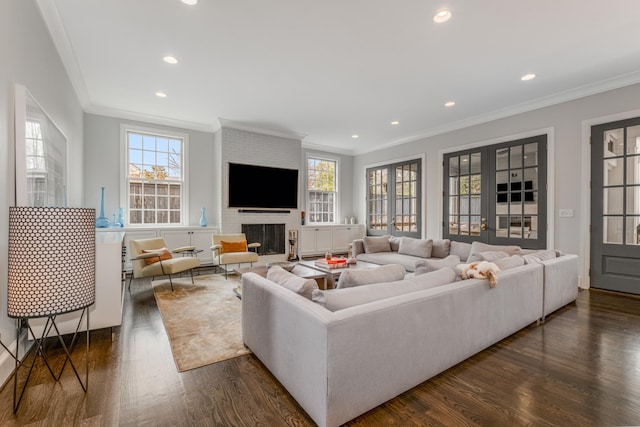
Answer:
129;237;200;290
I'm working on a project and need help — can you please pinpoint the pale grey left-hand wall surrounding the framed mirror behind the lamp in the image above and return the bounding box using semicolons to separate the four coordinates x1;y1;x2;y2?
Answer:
0;0;83;383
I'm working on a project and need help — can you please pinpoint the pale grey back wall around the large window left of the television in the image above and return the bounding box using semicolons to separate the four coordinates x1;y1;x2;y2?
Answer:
84;113;219;226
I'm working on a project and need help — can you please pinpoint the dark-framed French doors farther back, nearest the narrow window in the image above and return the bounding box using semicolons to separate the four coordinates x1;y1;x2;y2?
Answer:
366;160;422;238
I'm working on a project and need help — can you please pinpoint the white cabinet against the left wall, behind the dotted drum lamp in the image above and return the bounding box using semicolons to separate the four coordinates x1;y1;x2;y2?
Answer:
29;232;126;337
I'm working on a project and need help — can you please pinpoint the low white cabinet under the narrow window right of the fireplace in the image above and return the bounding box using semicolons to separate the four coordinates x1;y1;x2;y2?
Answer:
298;224;364;256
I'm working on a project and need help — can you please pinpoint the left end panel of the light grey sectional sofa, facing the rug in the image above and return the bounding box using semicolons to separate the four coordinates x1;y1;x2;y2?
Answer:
242;273;335;425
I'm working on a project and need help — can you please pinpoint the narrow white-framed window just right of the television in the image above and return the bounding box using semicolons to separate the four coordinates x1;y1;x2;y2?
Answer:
307;157;338;223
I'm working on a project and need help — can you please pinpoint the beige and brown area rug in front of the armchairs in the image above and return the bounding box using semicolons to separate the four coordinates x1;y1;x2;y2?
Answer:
152;275;250;372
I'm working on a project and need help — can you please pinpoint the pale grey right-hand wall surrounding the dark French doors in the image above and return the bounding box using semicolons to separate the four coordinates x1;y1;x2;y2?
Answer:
353;80;640;288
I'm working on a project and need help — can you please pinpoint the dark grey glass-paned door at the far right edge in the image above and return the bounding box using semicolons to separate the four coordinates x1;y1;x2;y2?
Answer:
590;118;640;294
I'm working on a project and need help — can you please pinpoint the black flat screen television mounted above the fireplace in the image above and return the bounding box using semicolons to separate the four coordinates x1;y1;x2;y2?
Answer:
228;163;298;209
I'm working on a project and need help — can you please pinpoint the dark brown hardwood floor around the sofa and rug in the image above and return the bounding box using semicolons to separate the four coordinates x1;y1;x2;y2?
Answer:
0;270;640;426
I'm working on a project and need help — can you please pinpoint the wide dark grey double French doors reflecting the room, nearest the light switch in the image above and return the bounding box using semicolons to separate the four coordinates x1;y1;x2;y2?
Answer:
442;135;547;249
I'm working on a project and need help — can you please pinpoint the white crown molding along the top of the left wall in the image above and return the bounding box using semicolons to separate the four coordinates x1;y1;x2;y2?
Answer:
36;0;91;109
